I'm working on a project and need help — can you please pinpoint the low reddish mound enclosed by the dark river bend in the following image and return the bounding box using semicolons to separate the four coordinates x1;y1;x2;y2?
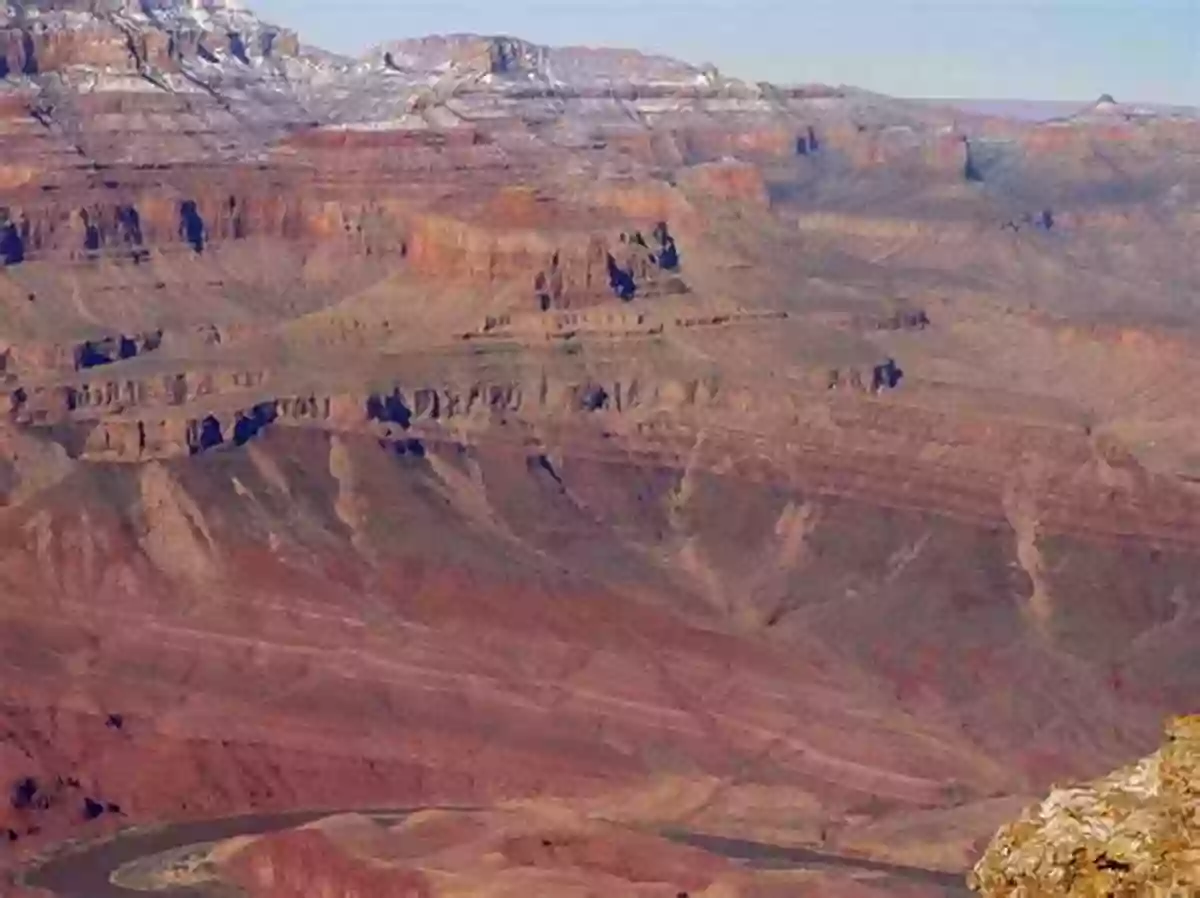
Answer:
217;813;916;898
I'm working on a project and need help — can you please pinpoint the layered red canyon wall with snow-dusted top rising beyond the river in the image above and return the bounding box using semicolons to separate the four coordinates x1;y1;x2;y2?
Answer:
0;0;1200;898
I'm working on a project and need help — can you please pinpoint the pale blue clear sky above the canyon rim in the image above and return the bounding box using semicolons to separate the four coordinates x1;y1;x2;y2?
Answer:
247;0;1200;106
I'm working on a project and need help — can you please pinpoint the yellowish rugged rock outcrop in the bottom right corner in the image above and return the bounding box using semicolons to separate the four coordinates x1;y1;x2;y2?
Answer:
971;717;1200;898
